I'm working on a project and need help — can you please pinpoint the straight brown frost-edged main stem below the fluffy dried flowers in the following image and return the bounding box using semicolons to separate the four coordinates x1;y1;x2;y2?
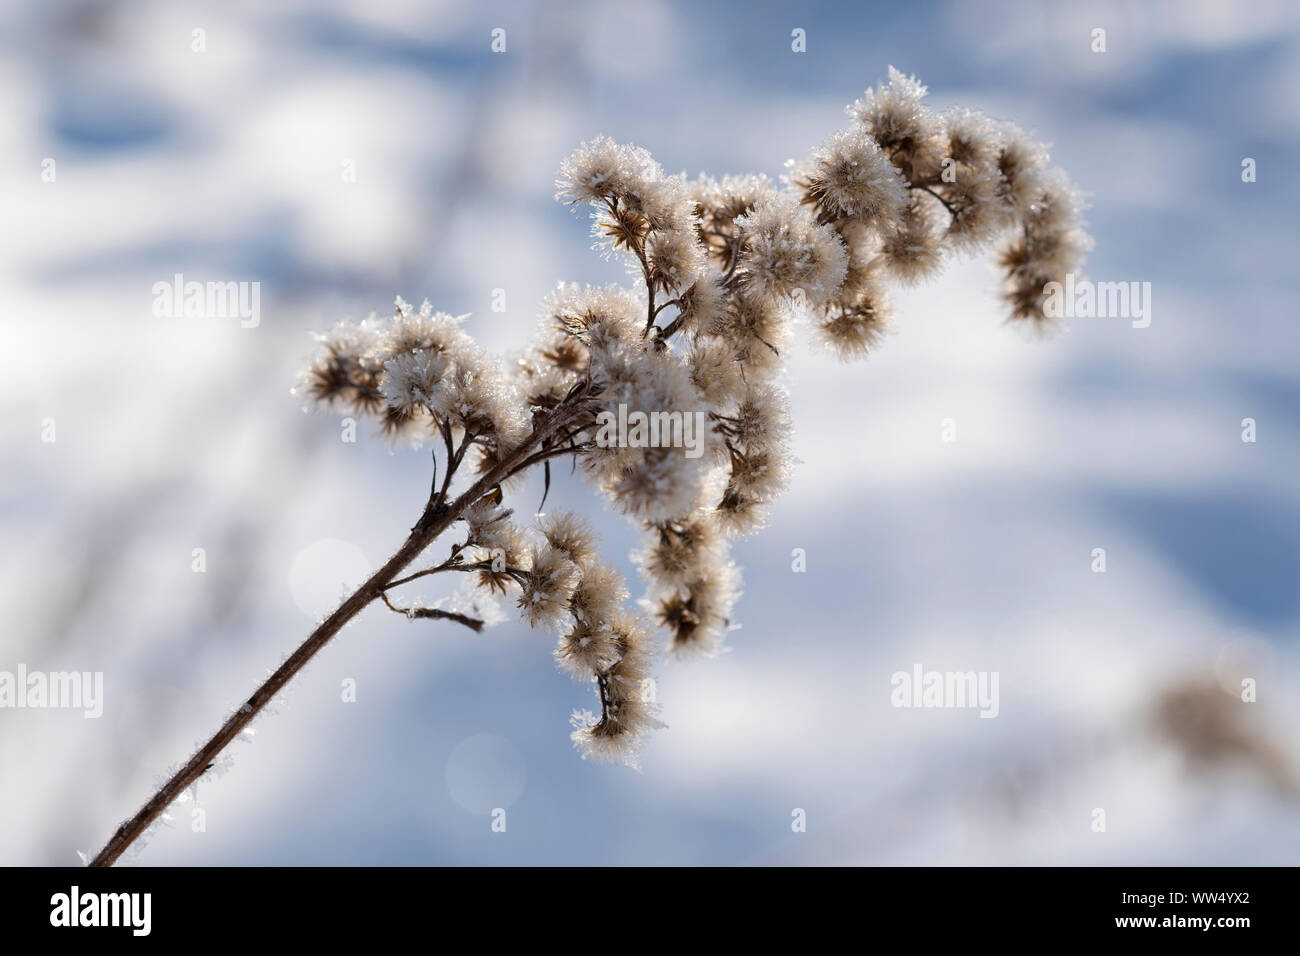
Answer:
90;389;585;866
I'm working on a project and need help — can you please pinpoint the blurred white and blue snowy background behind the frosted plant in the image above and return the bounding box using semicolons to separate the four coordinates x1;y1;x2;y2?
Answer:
0;0;1300;864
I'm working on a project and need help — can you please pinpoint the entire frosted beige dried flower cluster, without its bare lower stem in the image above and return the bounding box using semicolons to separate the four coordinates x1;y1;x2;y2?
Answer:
292;69;1088;761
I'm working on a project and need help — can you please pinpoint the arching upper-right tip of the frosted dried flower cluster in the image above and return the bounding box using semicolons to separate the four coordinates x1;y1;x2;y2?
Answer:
790;68;1091;356
